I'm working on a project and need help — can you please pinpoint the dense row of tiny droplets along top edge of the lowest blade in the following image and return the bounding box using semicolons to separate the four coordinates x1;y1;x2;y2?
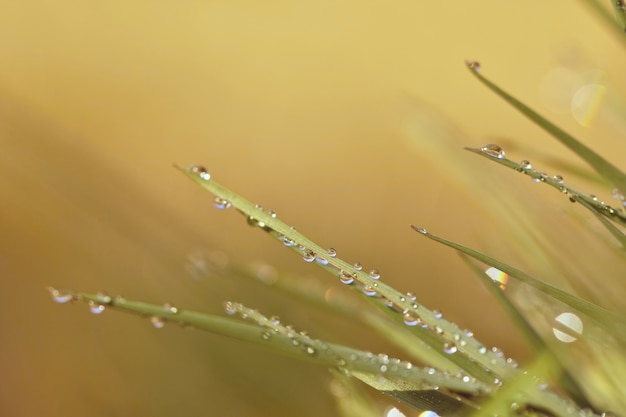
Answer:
224;301;490;395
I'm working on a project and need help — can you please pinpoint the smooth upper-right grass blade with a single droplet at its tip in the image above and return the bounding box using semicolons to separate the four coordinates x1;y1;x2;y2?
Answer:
468;63;626;192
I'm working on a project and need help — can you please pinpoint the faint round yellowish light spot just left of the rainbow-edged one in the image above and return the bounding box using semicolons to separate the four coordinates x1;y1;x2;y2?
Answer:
540;67;584;114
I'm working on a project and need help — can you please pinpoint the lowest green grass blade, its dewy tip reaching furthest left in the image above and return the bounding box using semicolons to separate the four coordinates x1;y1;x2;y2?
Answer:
49;288;491;412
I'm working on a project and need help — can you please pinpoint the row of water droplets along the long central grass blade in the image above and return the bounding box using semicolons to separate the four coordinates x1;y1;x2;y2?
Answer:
189;166;517;382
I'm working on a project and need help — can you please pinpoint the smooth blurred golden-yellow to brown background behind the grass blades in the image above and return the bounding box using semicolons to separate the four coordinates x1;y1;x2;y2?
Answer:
0;0;626;416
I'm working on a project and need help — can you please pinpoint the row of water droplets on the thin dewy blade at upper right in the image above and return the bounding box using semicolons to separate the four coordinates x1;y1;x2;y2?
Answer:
480;144;626;223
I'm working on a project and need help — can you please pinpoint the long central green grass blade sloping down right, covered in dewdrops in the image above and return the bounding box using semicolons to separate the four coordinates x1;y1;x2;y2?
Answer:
177;166;518;382
